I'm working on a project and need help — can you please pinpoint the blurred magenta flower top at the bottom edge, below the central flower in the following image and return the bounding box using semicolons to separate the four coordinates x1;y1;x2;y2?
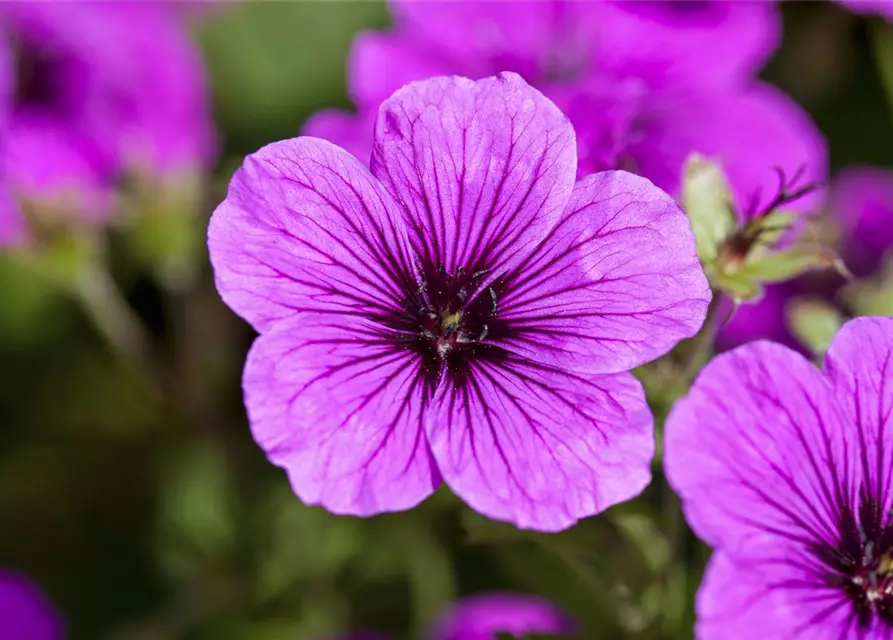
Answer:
431;593;576;640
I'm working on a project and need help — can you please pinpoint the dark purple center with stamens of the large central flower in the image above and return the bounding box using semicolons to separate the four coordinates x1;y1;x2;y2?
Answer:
387;266;509;385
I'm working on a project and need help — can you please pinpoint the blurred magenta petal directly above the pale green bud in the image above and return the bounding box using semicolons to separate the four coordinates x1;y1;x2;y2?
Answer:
633;84;828;211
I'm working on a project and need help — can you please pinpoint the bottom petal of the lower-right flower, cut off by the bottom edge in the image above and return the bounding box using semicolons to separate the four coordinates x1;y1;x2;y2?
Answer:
695;551;852;640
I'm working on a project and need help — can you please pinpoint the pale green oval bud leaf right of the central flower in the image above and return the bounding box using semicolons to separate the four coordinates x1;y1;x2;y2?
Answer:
682;154;737;262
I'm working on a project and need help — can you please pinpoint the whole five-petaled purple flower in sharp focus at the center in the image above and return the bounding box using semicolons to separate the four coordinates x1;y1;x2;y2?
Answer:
209;74;710;530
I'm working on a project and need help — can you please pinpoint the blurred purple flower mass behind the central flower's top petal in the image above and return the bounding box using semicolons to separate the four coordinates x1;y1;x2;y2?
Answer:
304;0;827;215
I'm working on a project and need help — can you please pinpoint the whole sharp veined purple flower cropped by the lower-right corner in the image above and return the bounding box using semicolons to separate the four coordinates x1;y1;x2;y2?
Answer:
664;318;893;640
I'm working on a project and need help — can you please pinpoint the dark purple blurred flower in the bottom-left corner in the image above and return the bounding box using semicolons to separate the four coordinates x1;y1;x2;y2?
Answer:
0;568;65;640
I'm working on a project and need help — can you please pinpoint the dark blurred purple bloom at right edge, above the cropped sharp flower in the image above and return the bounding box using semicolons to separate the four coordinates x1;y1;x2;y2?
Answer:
831;167;893;276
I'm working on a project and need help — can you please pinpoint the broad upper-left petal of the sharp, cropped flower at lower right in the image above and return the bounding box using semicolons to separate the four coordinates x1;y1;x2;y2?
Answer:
664;342;859;563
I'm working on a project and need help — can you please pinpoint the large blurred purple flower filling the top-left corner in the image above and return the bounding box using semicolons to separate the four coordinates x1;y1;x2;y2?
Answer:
0;0;214;245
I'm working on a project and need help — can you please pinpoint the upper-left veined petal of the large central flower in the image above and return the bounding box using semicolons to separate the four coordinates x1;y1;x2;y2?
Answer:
208;138;417;331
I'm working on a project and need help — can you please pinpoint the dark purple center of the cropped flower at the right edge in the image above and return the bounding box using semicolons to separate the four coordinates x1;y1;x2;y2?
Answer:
814;491;893;629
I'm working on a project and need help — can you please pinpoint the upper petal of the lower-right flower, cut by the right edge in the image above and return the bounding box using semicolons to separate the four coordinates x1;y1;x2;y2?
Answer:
825;318;893;521
